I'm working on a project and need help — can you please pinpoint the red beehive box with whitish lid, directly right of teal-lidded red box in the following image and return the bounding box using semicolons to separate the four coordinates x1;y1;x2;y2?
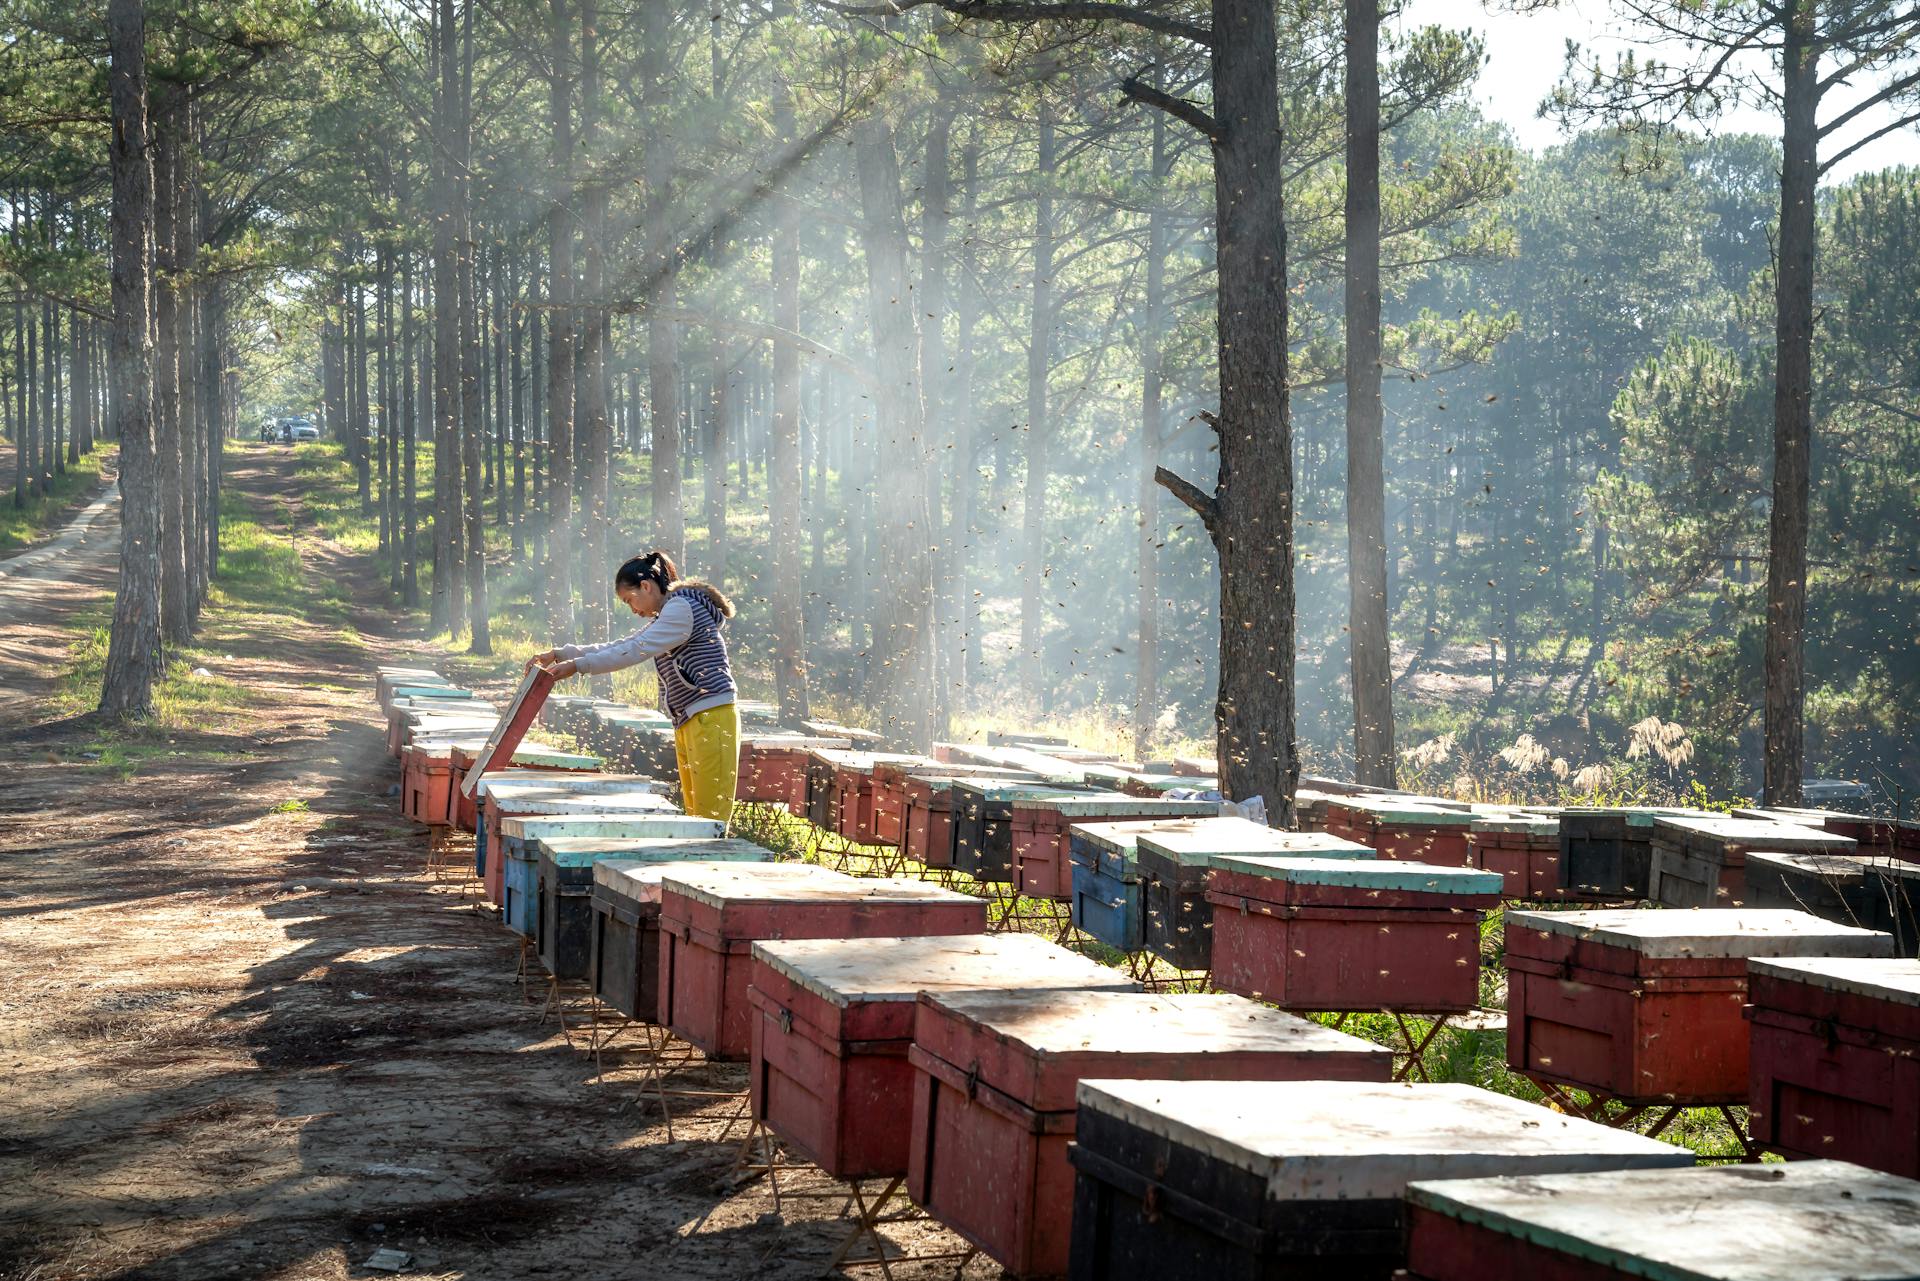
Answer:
1505;908;1893;1106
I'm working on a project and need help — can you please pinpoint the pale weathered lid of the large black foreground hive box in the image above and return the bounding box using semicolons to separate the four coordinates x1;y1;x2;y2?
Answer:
1079;1079;1693;1200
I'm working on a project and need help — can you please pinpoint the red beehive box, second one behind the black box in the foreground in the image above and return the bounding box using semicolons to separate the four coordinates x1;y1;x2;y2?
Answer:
749;933;1139;1179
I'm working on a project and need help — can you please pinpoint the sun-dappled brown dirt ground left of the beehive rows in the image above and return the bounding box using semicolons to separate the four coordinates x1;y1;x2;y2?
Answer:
0;451;995;1281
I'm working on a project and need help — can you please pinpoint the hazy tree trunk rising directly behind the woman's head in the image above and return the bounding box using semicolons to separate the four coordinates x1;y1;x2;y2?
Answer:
639;0;687;559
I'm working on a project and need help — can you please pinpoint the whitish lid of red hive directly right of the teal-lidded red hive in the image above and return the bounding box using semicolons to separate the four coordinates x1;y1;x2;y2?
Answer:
1505;906;1893;960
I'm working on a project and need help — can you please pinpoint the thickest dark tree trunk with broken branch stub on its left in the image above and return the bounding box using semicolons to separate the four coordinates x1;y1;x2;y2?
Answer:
1160;0;1300;826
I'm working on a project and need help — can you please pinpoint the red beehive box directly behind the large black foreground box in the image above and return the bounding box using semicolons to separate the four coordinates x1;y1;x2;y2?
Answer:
906;976;1392;1277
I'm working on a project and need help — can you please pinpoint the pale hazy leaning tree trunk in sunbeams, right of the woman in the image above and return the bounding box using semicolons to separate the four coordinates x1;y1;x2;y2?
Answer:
854;123;933;749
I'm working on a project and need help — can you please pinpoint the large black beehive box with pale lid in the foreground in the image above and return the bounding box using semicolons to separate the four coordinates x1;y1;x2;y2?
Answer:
1069;1081;1693;1281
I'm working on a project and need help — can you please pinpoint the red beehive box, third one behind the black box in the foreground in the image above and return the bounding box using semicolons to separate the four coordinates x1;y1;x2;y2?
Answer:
660;864;987;1058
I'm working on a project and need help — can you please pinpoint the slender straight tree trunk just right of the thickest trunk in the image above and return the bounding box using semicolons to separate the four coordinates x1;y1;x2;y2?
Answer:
1346;0;1394;787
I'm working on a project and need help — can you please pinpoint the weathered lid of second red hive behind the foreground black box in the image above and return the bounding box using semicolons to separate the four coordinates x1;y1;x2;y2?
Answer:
753;933;1140;1008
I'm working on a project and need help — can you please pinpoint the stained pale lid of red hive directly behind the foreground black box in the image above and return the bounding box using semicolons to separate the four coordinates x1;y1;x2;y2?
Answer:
920;991;1380;1058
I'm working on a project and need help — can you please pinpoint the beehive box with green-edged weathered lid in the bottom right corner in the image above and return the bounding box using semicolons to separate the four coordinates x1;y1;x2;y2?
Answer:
1407;1160;1920;1281
